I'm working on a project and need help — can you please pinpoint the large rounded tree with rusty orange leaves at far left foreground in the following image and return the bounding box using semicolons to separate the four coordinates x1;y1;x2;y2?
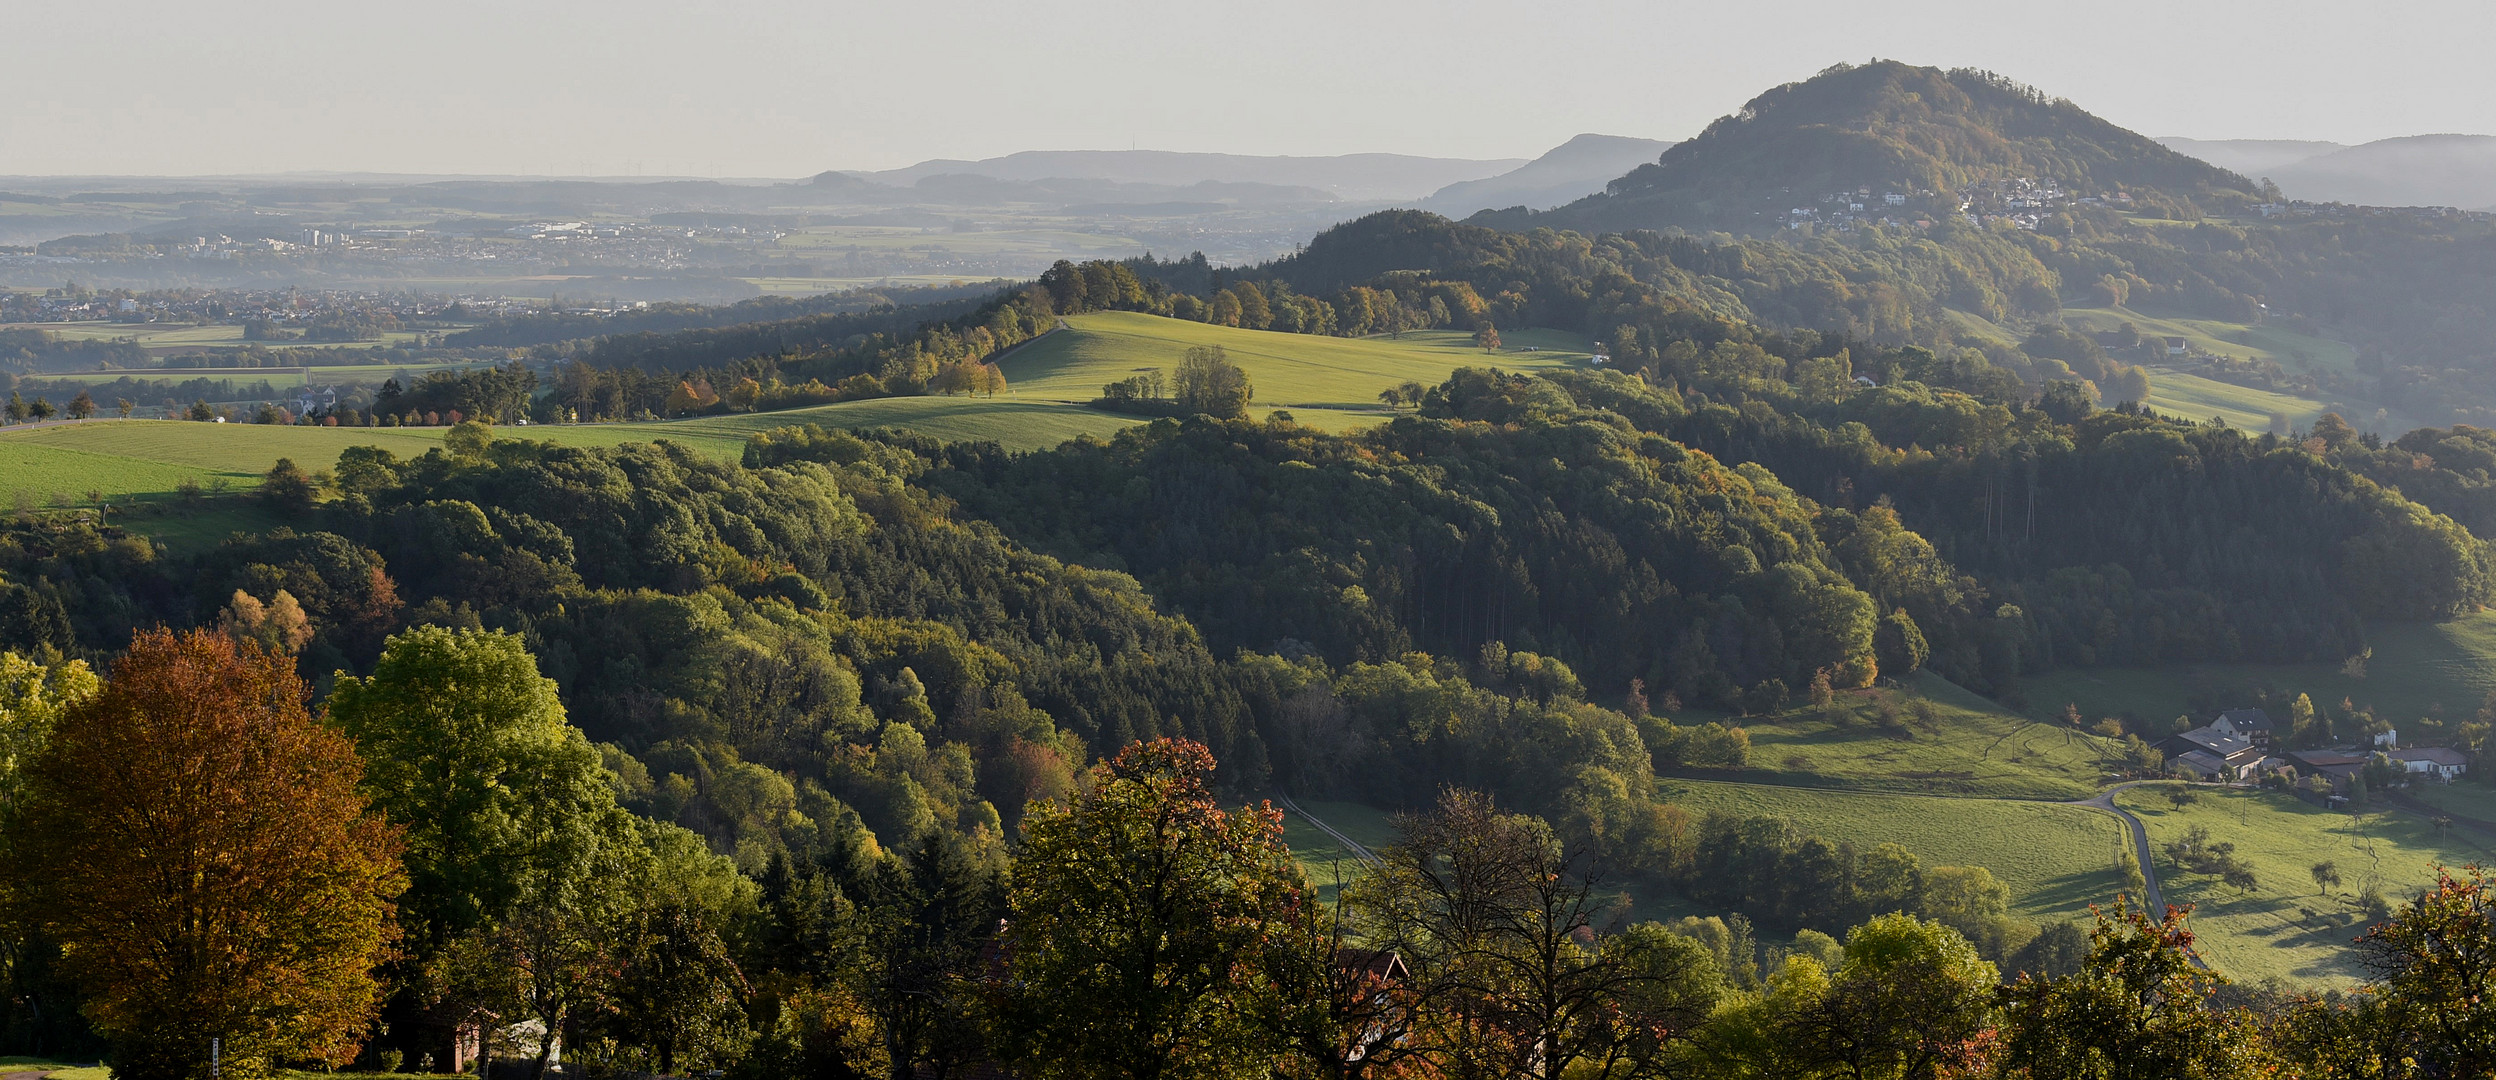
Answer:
12;629;404;1080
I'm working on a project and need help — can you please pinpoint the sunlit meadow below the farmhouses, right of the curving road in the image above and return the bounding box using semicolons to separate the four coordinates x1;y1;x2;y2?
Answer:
2117;786;2489;985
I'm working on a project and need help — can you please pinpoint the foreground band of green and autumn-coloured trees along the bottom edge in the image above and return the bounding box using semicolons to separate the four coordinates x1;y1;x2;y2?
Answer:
0;629;2496;1080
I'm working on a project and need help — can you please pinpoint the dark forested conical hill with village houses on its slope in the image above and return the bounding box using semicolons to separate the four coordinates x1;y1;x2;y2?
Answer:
1485;60;2256;232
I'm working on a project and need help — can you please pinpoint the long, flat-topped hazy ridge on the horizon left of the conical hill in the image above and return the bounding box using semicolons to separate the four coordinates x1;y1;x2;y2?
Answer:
849;150;1528;202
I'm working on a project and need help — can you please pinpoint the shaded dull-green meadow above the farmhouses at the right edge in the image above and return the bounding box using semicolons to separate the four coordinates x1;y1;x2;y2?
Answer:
2024;614;2496;726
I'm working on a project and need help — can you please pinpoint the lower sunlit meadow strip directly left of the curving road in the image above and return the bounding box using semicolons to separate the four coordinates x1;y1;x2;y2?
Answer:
1662;781;2124;920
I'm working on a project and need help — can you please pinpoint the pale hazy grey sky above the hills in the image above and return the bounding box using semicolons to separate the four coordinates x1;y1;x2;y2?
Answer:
0;0;2496;177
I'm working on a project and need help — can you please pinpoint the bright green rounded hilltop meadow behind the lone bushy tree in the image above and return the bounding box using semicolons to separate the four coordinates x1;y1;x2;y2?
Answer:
998;312;1590;419
